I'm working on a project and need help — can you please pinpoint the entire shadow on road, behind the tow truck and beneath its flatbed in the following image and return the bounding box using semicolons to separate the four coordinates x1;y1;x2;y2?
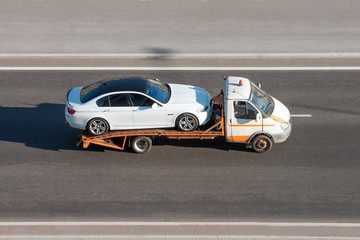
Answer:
0;103;247;152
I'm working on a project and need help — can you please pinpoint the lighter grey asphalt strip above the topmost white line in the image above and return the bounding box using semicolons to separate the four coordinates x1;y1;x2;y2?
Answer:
0;0;360;53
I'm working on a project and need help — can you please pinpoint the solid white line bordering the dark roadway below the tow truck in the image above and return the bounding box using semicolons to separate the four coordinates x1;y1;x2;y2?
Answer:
0;222;360;227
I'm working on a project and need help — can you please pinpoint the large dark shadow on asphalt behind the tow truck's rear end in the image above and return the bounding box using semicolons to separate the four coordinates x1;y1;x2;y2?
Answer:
0;103;91;151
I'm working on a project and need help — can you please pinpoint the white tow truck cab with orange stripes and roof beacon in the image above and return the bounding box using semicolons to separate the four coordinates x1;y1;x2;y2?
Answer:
224;76;291;152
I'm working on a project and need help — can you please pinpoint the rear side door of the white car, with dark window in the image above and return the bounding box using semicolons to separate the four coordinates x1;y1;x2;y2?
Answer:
97;93;134;130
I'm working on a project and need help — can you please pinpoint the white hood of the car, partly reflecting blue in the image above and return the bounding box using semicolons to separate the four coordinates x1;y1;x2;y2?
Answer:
168;84;211;107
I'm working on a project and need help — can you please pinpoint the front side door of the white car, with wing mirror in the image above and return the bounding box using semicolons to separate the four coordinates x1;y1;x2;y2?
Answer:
129;93;167;128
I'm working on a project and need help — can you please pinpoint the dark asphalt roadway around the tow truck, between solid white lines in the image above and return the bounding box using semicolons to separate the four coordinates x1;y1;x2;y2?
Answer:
0;68;360;222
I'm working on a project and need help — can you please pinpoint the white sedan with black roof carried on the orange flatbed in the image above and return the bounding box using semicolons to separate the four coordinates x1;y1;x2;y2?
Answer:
65;77;212;135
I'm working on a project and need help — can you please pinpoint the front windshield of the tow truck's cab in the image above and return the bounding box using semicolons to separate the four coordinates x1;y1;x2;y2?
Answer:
250;82;274;116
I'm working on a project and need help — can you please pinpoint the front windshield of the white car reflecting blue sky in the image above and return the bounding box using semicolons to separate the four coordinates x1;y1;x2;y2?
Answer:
145;79;171;103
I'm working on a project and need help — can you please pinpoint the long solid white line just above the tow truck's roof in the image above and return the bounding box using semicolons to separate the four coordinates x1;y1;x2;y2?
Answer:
0;66;360;71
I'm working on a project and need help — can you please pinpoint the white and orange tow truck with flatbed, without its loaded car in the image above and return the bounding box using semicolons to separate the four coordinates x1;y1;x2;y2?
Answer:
77;76;292;153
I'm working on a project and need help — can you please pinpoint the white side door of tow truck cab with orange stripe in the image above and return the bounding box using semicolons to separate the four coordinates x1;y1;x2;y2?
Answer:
228;101;263;142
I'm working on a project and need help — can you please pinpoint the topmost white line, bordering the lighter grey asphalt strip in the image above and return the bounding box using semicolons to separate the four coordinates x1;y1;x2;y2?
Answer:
0;52;360;58
